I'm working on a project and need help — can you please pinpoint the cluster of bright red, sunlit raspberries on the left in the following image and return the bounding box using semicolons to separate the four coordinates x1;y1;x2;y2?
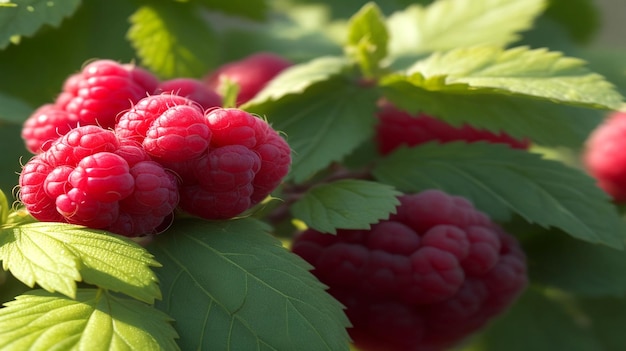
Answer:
19;60;291;236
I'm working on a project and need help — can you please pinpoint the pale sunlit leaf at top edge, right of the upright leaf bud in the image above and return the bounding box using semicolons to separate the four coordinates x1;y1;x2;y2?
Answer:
387;0;546;56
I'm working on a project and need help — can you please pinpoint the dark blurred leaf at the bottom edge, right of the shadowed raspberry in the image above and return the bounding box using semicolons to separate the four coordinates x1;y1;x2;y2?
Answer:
472;289;603;351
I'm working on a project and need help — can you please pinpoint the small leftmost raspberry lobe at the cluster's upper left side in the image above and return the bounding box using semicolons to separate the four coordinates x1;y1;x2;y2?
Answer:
22;104;78;154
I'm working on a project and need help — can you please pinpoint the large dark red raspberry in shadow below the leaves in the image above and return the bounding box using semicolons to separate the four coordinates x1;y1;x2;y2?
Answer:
292;190;527;351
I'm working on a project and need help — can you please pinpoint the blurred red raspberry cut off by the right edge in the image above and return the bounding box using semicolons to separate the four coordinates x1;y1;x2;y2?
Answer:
583;112;626;203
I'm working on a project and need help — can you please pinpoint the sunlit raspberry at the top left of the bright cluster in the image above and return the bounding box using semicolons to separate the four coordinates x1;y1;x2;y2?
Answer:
55;60;158;128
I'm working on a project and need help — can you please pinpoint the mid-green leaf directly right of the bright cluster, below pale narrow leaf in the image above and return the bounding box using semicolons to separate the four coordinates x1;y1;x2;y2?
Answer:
243;77;378;183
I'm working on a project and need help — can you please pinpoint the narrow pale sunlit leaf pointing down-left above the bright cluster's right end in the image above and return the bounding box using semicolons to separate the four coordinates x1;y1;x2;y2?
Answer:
241;56;349;106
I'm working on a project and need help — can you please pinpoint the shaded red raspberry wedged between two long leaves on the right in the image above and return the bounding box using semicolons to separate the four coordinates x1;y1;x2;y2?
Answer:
376;102;530;155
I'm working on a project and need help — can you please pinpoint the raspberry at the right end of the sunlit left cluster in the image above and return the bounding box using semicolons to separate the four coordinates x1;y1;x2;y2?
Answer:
177;108;291;219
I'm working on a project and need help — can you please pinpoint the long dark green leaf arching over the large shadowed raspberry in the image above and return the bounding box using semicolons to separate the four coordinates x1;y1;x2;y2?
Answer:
373;142;624;248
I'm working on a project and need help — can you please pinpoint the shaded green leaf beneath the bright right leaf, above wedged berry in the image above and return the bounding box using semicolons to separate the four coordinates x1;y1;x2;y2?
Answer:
381;74;605;148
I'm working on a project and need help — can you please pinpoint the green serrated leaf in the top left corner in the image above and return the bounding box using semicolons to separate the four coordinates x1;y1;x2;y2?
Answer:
0;0;81;49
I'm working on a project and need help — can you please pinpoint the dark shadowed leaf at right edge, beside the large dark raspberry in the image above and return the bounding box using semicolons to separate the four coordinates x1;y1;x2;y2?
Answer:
524;232;626;297
